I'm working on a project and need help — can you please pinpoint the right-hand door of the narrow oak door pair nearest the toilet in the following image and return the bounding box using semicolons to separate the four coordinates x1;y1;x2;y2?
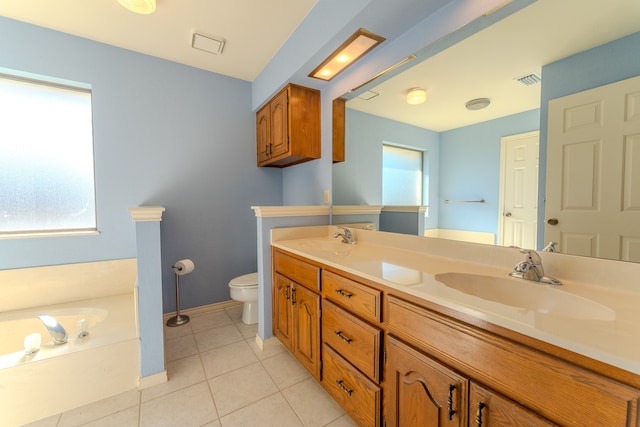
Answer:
291;284;320;381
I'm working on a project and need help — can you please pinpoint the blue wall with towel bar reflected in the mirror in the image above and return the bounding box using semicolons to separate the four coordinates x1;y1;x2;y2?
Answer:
438;109;540;237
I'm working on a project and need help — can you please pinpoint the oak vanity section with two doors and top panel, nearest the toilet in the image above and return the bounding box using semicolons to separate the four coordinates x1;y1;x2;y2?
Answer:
272;251;321;381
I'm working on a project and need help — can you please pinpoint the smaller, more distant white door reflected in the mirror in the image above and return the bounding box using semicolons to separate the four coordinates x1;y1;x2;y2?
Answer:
498;131;540;249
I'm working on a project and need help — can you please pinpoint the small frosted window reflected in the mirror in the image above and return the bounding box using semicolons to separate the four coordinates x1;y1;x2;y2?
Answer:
382;145;426;206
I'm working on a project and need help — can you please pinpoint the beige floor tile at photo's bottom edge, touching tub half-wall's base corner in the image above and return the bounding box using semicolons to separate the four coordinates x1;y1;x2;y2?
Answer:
140;382;218;427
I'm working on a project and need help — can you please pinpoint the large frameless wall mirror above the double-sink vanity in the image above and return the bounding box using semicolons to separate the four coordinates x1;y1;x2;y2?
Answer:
333;0;640;262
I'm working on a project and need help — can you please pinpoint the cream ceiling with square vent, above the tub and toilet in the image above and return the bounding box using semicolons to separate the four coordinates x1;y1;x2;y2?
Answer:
0;0;317;81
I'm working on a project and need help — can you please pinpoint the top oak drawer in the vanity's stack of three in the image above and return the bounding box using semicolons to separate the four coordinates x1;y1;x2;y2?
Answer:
322;270;382;322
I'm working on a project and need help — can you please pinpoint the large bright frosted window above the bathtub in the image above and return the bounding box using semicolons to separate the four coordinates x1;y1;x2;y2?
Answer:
0;74;97;236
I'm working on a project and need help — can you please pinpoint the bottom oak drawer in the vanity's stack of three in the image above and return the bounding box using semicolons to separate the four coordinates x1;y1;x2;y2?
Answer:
322;344;382;426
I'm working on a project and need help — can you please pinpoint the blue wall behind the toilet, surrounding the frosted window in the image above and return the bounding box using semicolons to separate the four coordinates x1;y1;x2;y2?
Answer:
0;17;282;312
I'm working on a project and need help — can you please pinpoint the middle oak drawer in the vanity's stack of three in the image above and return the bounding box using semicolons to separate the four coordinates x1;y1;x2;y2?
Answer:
322;301;382;382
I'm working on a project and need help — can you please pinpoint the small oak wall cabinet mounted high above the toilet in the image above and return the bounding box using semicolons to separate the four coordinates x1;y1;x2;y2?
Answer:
256;84;321;168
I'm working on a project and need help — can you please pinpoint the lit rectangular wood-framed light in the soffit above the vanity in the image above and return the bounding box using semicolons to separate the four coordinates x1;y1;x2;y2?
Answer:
309;28;386;81
